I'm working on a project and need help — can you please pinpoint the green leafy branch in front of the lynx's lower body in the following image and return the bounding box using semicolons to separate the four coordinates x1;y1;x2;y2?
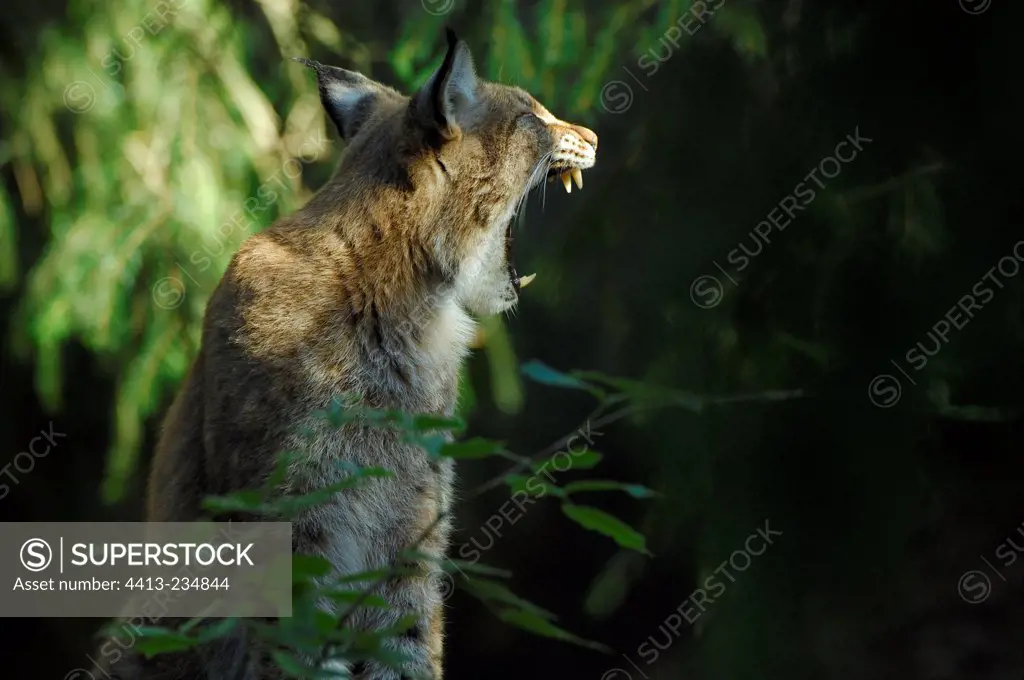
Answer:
128;364;654;678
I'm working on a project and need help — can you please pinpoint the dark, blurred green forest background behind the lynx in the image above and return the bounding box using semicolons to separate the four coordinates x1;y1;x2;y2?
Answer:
0;0;1024;680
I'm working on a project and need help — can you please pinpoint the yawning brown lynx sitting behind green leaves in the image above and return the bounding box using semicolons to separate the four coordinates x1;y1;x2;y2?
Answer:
100;31;597;680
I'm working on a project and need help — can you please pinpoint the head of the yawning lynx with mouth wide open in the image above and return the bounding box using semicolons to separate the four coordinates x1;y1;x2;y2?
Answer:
300;31;597;314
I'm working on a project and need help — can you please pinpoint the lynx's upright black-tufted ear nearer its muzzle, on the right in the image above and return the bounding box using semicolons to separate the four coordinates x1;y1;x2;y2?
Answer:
413;29;478;139
